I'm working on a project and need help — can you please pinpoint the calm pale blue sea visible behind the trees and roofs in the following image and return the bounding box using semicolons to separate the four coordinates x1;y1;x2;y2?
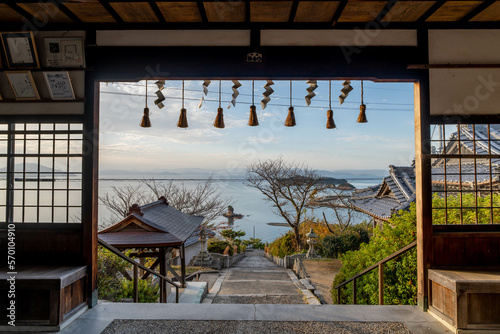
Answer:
99;178;382;242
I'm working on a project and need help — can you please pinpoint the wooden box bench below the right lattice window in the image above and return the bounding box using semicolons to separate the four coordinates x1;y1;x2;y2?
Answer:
429;269;500;332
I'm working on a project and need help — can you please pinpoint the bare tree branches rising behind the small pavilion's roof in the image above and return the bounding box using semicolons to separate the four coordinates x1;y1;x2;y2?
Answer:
99;177;232;230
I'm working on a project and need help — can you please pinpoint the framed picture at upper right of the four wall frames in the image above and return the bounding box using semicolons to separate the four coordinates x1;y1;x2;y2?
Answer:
43;37;85;68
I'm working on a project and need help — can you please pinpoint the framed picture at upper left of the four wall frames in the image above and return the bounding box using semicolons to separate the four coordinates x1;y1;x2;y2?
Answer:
0;31;40;69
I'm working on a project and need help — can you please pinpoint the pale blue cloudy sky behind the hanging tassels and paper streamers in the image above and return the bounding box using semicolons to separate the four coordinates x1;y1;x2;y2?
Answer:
96;80;414;172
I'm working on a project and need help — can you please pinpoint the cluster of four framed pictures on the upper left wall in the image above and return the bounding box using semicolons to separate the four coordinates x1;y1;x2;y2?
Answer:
0;32;85;102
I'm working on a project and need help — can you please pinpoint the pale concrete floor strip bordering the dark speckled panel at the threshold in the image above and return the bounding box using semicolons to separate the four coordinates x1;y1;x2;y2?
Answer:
50;303;450;334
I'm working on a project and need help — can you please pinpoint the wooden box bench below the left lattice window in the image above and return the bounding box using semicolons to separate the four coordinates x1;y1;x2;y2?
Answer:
0;266;87;326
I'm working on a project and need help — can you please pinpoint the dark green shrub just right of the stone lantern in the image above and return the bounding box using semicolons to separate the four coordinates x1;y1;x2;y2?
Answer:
318;223;370;259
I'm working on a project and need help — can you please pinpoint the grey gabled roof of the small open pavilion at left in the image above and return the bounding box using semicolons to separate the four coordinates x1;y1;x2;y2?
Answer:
99;197;204;247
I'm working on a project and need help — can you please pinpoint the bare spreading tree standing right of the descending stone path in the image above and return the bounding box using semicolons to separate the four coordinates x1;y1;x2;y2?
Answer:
245;157;324;250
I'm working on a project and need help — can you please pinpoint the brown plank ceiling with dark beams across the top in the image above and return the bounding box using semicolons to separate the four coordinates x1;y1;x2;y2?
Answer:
0;0;500;29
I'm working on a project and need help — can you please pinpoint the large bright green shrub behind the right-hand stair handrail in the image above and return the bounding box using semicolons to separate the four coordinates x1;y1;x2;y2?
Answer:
331;203;417;305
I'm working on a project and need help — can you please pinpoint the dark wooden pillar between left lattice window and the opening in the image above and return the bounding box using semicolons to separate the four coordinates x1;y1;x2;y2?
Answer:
82;72;99;307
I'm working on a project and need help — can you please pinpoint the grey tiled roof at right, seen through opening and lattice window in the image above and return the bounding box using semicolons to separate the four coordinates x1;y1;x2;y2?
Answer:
351;125;500;220
